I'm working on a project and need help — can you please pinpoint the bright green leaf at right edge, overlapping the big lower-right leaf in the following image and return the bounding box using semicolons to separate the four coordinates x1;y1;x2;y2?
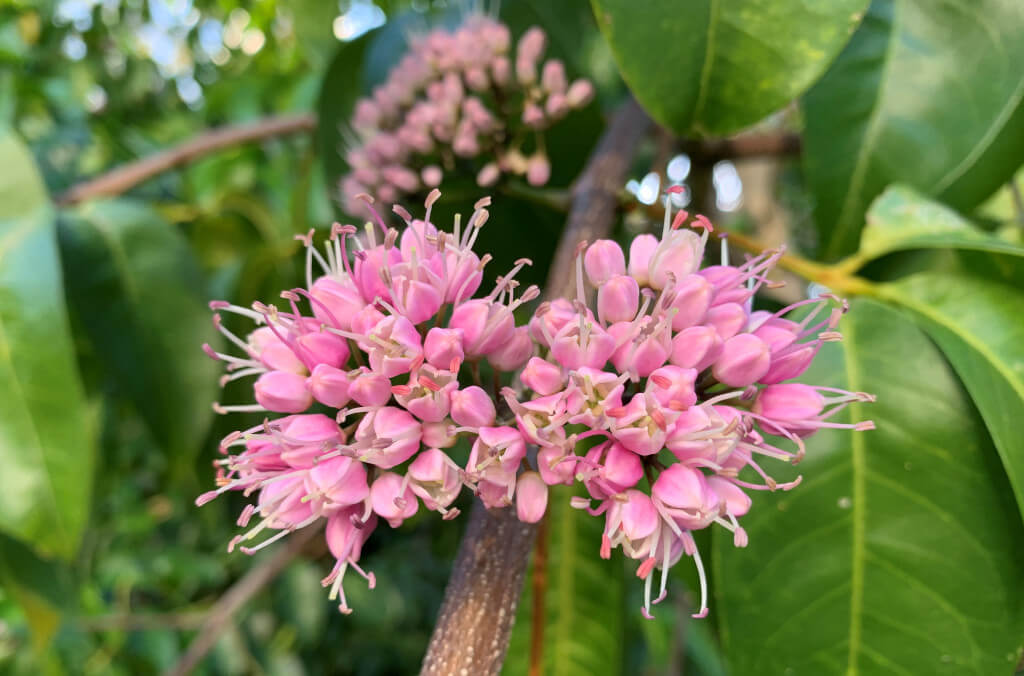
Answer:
883;272;1024;522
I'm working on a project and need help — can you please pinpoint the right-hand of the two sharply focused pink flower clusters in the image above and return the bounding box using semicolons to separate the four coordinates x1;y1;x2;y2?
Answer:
503;188;873;618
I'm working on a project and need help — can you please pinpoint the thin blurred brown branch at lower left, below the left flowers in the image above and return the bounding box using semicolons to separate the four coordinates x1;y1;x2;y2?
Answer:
165;527;323;676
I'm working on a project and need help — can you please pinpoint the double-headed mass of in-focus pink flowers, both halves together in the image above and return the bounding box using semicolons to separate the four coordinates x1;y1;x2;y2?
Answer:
198;189;873;617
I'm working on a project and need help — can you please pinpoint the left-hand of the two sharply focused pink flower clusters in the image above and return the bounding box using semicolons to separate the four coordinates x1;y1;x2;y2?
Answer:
197;189;547;612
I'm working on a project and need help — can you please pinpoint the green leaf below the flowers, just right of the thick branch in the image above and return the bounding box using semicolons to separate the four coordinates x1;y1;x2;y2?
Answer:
503;485;622;676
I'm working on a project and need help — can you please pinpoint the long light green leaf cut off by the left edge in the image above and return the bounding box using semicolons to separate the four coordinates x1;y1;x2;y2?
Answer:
0;131;95;557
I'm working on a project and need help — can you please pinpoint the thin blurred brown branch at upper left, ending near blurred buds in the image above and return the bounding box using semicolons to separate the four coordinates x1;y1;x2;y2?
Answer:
56;113;316;206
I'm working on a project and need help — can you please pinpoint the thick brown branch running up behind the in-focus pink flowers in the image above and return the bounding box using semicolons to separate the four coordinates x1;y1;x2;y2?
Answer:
420;100;651;676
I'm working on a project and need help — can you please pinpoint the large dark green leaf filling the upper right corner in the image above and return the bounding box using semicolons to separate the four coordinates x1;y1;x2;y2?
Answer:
804;0;1024;258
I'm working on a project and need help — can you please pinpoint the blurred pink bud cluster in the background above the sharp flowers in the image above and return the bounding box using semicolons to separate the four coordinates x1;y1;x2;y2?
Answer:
341;14;594;214
